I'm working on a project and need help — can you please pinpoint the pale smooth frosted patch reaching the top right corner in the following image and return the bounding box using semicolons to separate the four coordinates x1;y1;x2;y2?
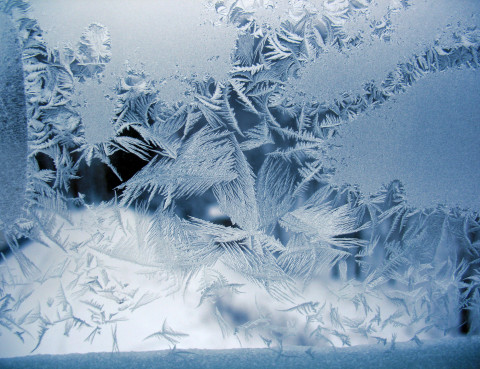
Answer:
292;0;480;101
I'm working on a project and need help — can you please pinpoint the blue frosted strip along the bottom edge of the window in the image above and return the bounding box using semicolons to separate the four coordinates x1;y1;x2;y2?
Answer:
0;338;480;369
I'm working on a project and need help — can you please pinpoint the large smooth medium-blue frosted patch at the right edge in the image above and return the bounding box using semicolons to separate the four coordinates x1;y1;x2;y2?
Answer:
333;70;480;210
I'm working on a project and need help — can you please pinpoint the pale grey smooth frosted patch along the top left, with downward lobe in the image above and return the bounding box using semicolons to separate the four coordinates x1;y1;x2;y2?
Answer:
31;0;237;143
